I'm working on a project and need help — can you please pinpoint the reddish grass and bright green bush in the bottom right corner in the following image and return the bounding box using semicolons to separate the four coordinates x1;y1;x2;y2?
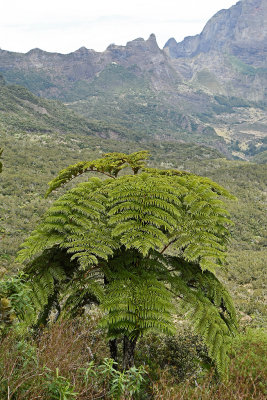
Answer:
153;329;267;400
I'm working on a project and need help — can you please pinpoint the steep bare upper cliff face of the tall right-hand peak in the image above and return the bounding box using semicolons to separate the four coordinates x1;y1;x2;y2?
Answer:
165;0;267;67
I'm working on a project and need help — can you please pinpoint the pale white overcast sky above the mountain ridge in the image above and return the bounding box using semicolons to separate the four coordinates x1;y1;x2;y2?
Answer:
0;0;237;54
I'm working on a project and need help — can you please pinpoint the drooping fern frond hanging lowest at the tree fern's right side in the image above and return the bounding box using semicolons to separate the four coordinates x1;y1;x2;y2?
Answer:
168;257;237;375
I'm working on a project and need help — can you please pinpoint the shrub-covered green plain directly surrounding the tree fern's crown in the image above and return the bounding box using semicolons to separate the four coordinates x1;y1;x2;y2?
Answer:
0;125;267;325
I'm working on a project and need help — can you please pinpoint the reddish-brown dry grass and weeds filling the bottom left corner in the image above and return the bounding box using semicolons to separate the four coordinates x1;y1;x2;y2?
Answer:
0;321;108;400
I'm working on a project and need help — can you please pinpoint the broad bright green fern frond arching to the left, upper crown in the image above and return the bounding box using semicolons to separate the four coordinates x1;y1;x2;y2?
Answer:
18;178;116;267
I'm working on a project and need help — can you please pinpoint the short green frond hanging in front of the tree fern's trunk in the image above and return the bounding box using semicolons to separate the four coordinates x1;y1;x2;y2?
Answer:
101;270;174;336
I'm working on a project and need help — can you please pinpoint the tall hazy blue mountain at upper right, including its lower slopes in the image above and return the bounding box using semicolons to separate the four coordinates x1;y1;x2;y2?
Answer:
164;0;267;104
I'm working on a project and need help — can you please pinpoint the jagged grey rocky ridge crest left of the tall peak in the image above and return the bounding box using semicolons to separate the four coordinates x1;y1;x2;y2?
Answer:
0;34;182;100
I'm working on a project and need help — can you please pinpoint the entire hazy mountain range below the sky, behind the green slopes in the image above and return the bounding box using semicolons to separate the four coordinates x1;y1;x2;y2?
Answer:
0;0;267;159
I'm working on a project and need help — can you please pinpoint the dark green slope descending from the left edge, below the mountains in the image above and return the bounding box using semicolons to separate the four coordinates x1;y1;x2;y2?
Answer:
0;75;136;138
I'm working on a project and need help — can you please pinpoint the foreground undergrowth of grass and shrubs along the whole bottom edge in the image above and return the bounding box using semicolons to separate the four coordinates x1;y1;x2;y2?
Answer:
0;322;266;400
